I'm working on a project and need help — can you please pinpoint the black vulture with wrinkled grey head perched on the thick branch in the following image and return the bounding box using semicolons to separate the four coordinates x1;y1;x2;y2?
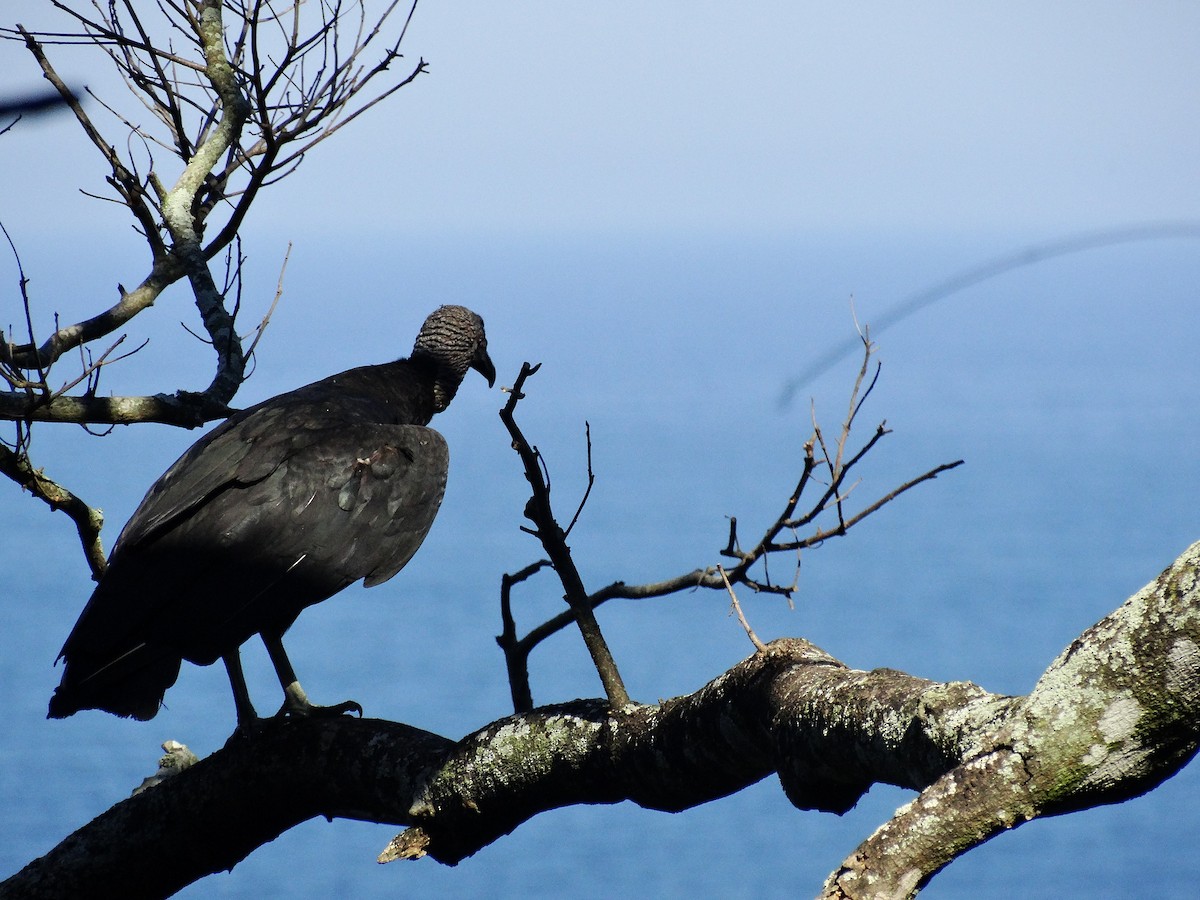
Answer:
49;306;496;726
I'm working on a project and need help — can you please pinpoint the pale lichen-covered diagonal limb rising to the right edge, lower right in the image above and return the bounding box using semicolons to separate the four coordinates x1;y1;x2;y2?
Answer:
824;544;1200;898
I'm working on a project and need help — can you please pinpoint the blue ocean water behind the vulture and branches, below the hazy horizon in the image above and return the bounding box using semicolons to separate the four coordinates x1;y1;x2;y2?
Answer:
0;234;1200;898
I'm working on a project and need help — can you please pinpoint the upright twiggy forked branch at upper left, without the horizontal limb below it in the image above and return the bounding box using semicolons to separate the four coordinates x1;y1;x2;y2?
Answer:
0;0;424;408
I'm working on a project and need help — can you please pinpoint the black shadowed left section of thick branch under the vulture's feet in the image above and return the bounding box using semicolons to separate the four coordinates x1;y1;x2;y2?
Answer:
0;719;451;900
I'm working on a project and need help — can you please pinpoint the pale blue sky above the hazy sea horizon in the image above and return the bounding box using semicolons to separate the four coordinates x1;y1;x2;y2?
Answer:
0;0;1200;240
